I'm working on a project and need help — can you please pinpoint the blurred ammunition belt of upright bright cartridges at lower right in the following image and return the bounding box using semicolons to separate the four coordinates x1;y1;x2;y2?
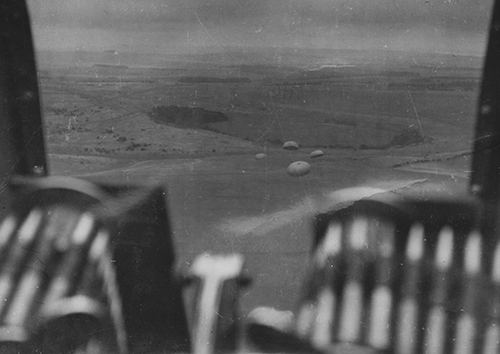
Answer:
248;194;500;354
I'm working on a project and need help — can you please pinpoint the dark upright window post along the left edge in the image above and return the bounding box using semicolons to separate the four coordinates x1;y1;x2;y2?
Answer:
0;0;47;206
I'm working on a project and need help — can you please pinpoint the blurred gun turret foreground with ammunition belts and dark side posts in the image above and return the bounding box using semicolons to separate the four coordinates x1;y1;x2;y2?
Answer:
0;0;500;354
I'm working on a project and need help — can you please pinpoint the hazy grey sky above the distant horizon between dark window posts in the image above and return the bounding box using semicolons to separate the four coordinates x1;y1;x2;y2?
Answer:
29;0;492;54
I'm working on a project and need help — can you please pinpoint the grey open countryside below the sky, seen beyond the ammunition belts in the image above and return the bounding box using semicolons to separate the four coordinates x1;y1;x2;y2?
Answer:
37;47;482;309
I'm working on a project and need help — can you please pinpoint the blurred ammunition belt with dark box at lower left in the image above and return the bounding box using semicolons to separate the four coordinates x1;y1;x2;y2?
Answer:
0;177;189;353
